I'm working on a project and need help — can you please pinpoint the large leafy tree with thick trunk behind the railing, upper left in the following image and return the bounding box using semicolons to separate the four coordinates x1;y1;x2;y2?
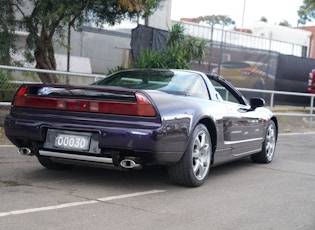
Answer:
6;0;164;83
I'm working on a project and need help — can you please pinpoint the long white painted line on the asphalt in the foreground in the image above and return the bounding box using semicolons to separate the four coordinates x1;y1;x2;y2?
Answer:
0;190;165;217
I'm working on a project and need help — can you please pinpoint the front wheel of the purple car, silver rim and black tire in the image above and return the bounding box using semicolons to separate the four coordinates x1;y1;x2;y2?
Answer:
251;120;277;163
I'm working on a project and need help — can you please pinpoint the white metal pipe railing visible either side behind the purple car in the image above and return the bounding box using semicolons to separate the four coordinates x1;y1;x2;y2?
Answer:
0;65;315;128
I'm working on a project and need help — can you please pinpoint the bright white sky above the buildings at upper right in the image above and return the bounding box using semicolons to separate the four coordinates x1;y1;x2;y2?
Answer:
171;0;315;28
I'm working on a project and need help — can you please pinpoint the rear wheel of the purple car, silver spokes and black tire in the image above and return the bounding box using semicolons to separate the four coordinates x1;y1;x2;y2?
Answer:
168;124;212;187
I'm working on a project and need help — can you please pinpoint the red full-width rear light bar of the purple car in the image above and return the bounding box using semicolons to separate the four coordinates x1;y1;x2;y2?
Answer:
12;86;156;117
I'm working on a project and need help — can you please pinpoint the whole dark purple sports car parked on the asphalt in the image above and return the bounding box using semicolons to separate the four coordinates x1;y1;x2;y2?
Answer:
5;69;278;187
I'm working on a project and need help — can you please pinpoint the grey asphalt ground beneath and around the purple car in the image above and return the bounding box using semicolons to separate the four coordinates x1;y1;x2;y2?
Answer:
0;133;315;230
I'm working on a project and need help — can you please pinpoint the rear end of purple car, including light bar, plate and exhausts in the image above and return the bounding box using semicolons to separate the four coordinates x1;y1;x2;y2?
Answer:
5;84;185;168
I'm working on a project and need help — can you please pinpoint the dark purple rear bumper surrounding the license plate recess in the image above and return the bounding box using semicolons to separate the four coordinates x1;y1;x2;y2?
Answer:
5;115;188;165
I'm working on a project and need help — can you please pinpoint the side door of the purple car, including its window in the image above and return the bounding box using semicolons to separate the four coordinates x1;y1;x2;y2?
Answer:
210;74;264;156
